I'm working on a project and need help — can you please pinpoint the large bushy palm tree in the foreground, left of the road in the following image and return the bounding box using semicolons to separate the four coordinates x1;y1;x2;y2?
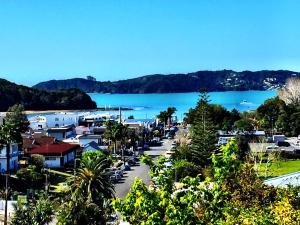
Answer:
59;157;114;225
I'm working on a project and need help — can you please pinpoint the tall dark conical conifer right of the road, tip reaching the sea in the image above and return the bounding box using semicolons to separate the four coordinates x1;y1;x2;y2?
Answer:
191;92;217;167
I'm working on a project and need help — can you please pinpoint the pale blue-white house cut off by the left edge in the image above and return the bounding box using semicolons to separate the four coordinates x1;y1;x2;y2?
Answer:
0;143;19;173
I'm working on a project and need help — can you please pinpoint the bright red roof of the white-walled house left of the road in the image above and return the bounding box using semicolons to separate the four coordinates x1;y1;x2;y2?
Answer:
29;143;79;155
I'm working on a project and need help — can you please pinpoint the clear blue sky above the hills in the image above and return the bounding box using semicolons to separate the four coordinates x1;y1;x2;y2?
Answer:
0;0;300;85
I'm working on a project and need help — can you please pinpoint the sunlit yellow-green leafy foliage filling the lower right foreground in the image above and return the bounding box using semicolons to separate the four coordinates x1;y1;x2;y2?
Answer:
113;141;300;225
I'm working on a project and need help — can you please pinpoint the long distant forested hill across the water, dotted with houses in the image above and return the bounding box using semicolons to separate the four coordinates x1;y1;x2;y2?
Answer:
34;70;300;93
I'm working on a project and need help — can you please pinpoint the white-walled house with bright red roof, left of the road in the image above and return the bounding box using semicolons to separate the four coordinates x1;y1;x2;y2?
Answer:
30;143;80;168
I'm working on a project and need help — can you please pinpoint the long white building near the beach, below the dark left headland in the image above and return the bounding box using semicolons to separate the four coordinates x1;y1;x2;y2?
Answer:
28;112;79;130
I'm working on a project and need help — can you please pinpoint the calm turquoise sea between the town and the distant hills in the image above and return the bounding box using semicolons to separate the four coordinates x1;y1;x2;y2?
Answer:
89;90;276;120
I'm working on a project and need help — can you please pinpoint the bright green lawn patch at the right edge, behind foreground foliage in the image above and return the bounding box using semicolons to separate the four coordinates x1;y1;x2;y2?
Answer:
258;160;300;178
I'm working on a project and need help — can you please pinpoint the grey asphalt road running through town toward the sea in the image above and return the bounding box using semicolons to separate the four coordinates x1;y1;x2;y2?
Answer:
115;139;173;198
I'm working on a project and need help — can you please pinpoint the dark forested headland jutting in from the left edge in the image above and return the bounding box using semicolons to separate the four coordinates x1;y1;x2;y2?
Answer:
0;79;96;112
